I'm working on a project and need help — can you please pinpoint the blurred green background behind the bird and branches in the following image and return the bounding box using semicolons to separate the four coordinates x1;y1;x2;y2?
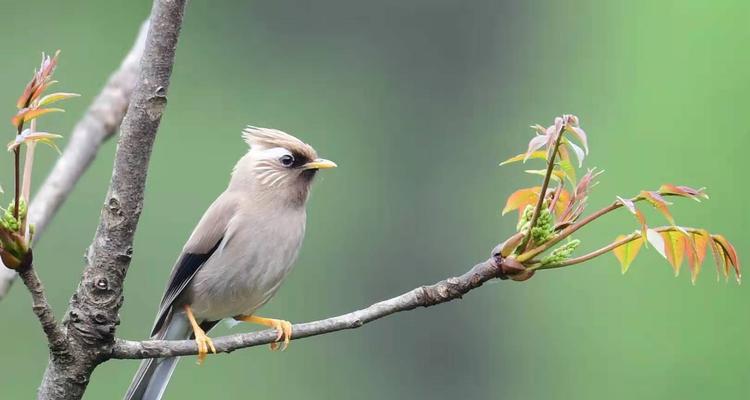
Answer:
0;0;750;399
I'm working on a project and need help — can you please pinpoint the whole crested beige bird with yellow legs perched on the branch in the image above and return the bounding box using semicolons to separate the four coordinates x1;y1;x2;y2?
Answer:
125;126;337;400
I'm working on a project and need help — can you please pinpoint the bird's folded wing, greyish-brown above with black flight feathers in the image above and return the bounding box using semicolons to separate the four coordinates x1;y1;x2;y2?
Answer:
151;192;238;335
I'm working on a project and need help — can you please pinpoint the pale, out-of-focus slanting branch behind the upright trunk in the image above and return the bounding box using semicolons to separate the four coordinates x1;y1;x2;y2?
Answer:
0;22;148;300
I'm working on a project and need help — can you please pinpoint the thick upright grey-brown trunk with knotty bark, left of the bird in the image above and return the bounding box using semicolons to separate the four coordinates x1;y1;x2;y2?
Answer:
38;0;185;399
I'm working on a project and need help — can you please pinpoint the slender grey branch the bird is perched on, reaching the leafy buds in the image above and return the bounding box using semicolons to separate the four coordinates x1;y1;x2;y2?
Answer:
111;257;504;359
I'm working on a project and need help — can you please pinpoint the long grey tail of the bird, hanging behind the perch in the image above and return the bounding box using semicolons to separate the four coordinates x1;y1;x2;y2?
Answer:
125;313;192;400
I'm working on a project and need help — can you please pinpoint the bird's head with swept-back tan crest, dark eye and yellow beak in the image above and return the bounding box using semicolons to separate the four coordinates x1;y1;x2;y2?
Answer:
232;126;336;204
